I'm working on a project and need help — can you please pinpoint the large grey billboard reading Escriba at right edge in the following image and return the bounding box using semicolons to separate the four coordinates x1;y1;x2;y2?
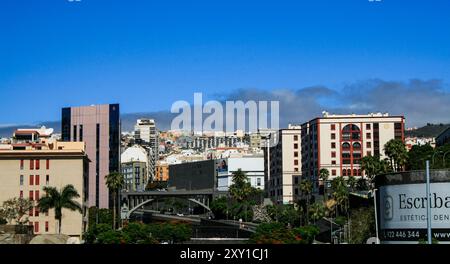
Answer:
378;182;450;243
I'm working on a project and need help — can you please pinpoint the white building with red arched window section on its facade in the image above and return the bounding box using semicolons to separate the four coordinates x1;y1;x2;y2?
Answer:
301;112;405;191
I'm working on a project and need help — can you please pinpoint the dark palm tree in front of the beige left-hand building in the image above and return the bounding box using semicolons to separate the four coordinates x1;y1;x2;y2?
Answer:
38;184;83;234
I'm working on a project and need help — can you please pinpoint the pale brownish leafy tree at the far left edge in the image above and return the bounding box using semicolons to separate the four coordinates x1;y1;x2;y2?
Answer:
0;197;33;225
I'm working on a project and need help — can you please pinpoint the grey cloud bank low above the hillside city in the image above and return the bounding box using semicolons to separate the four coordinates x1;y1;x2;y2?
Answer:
0;79;450;136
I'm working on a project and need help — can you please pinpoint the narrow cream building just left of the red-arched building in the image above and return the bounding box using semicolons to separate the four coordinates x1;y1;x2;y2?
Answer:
264;125;302;204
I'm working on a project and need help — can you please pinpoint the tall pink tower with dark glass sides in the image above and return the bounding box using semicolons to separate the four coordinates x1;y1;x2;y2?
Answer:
61;104;120;208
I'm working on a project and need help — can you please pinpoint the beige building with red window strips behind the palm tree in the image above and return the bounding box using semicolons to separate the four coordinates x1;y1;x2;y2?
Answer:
0;130;89;238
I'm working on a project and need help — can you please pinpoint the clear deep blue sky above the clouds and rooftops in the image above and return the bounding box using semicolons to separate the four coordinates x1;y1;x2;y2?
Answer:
0;0;450;125
